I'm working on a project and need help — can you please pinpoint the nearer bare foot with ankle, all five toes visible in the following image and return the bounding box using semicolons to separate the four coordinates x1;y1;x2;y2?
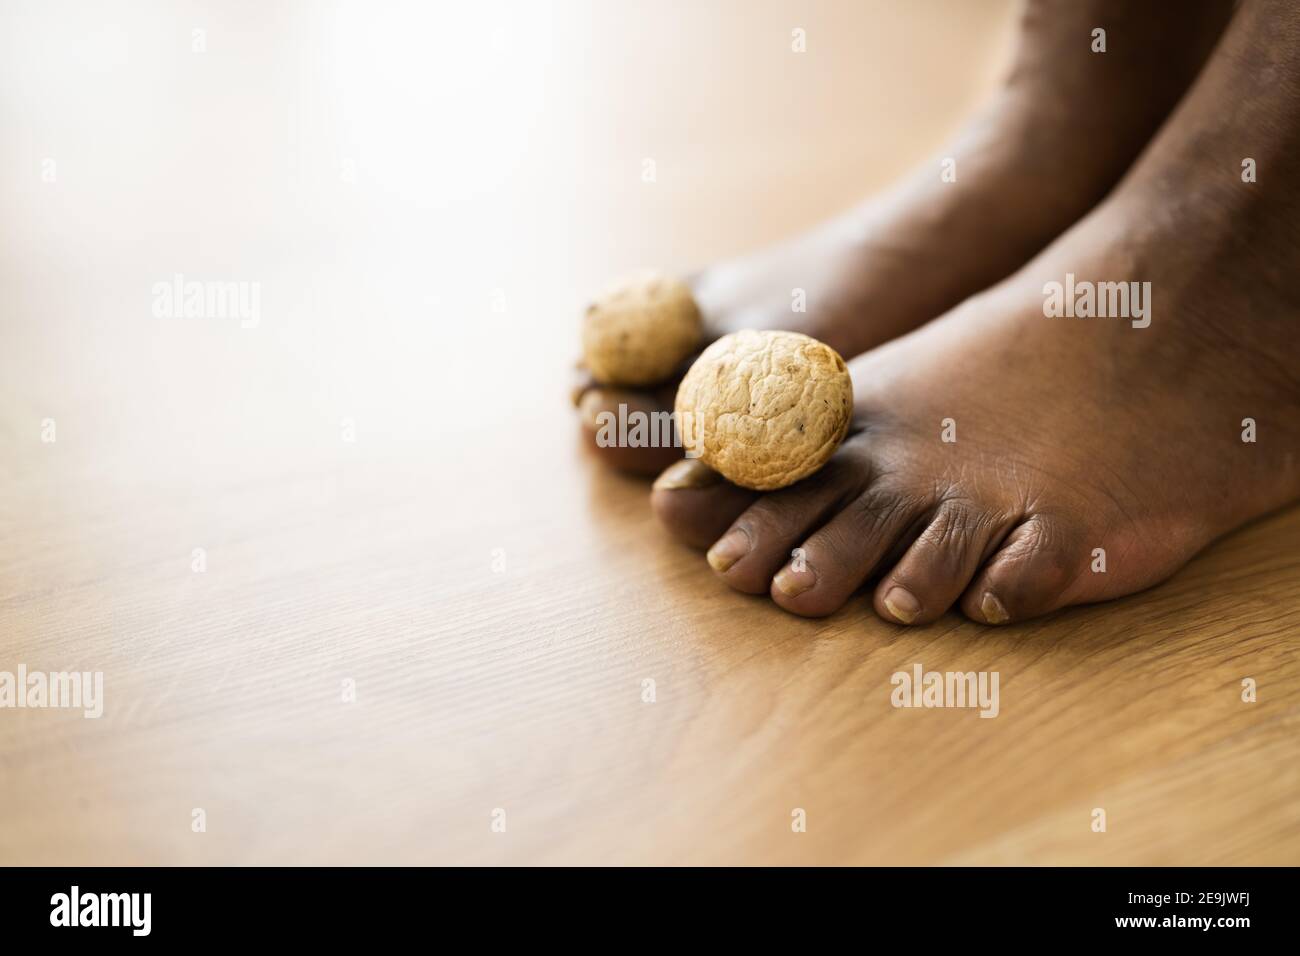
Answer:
653;4;1300;624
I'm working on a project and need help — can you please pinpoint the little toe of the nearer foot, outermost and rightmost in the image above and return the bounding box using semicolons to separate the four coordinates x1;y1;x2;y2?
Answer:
962;515;1088;624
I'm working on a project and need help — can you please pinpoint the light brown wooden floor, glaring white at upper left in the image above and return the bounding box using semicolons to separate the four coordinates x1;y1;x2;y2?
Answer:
0;0;1300;864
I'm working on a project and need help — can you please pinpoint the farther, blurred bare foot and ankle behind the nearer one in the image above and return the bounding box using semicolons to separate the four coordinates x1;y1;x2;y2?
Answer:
577;0;1231;473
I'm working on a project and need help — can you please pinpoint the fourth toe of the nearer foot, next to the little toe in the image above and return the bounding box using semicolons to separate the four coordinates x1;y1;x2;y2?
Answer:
875;499;1013;624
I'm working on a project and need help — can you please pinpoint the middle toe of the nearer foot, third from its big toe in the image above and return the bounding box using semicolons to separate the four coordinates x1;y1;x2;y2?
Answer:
771;483;933;617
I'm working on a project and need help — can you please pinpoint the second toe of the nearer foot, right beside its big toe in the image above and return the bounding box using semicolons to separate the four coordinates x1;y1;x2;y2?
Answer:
709;449;870;594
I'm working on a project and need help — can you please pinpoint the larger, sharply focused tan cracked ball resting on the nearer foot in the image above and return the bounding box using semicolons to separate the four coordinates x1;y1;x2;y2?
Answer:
676;332;853;492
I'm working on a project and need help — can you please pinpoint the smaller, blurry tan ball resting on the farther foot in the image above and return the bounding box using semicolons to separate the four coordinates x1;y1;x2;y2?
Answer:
582;272;703;386
